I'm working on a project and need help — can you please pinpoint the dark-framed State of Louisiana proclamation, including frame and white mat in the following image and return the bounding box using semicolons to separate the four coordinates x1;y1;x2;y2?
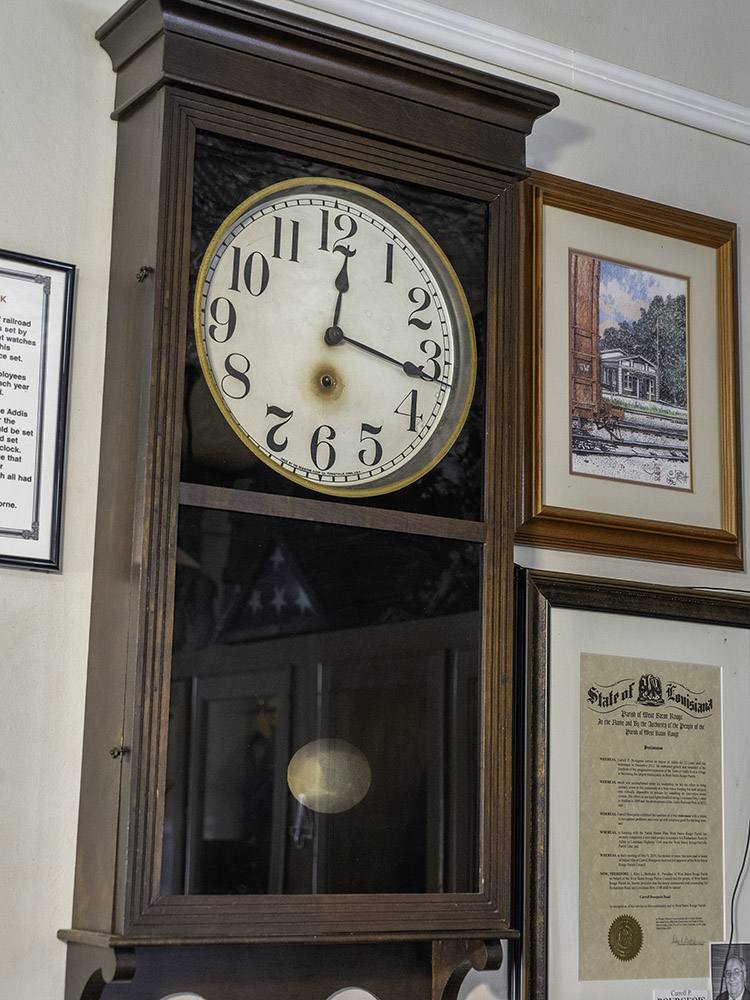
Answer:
518;571;750;1000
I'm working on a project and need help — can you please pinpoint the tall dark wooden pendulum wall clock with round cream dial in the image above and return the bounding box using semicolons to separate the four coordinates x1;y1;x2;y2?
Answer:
60;0;557;1000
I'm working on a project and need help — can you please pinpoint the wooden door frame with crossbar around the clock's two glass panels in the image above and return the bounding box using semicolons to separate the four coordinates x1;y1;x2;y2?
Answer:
108;93;517;943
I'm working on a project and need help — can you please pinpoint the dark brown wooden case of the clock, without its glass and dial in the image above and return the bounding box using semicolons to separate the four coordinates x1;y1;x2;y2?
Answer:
61;0;558;1000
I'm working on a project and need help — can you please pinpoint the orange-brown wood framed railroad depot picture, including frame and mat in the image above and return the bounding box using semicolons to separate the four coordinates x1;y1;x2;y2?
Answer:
516;173;743;569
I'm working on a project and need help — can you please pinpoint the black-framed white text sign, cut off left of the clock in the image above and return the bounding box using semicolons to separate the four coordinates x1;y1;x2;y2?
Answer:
0;250;75;570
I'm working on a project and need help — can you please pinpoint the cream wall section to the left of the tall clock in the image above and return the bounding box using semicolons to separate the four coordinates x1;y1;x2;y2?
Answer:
0;0;115;1000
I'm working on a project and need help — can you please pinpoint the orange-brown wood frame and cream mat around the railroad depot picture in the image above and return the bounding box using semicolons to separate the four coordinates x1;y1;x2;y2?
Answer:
516;172;743;569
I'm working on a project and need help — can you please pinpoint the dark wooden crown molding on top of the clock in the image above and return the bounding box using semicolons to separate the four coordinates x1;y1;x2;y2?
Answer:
96;0;559;147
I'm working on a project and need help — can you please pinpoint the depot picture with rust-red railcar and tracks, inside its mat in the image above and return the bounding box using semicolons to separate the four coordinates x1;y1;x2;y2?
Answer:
570;251;691;490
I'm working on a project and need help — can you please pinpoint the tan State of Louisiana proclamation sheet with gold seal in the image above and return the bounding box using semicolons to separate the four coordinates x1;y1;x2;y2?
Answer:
578;653;724;980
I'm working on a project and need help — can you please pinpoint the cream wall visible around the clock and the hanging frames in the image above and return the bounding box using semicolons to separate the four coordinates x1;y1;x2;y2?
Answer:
0;0;750;1000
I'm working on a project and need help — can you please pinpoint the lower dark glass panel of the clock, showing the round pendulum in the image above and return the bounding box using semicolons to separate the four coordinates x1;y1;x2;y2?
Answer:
162;507;481;895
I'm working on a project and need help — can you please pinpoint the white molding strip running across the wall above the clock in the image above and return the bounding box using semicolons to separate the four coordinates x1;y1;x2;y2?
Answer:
288;0;750;144
